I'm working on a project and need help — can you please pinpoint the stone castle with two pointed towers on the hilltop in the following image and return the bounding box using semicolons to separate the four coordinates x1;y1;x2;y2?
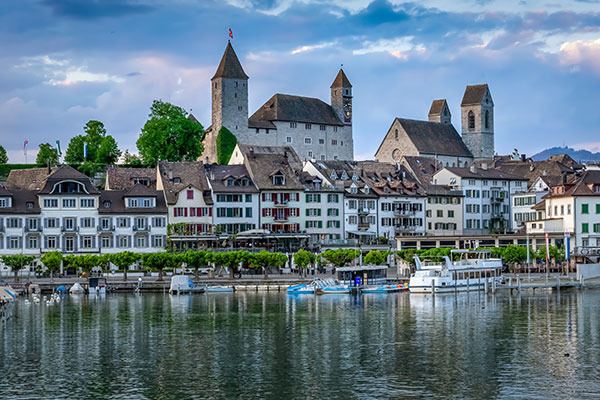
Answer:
203;42;354;163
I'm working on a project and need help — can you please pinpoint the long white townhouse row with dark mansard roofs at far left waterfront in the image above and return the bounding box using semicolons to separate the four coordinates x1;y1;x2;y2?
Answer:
0;165;167;255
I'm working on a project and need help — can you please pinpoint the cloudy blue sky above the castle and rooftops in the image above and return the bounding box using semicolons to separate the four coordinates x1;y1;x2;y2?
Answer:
0;0;600;163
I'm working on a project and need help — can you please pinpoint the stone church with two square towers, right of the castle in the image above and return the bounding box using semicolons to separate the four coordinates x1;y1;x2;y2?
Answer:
375;84;494;167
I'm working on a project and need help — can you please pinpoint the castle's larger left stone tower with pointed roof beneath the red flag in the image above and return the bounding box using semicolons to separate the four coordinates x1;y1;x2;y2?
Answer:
210;42;248;138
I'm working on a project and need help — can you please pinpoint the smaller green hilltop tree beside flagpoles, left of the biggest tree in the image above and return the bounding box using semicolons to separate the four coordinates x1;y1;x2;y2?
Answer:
65;120;121;164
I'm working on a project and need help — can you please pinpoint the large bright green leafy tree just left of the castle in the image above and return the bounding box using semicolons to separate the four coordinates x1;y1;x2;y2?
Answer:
136;100;204;165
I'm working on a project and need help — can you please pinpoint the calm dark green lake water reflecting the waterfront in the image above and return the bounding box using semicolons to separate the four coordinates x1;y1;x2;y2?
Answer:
0;290;600;399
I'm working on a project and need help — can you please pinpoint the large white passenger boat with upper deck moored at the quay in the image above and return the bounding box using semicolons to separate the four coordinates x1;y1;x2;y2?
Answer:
408;250;502;293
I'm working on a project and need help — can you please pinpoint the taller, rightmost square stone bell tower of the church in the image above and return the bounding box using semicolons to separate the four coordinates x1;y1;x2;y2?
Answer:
460;84;494;160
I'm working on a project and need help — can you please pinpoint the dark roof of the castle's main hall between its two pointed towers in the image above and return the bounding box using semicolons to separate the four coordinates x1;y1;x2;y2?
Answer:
248;93;343;129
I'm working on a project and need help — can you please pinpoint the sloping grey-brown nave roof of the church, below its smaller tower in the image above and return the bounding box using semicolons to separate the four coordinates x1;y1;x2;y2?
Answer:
396;118;473;157
